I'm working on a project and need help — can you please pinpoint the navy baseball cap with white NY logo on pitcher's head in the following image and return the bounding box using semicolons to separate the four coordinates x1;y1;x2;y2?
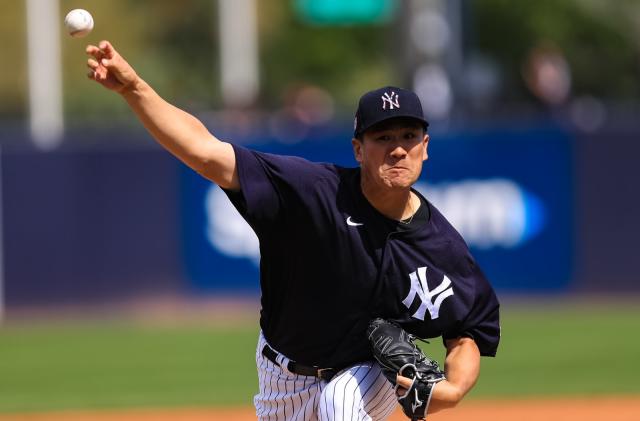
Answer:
353;86;429;137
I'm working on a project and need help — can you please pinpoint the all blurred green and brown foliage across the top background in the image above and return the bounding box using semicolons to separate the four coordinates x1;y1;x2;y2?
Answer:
0;0;640;125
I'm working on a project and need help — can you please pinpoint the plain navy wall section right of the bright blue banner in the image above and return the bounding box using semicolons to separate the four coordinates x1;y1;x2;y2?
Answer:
574;131;640;293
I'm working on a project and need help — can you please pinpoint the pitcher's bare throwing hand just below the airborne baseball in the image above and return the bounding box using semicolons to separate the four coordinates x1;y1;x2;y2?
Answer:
86;41;138;93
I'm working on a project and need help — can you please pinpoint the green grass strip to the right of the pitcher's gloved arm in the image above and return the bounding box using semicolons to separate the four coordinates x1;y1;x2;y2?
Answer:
472;303;640;396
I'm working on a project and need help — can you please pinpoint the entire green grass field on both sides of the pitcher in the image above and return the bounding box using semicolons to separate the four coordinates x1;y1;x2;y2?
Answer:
0;304;640;412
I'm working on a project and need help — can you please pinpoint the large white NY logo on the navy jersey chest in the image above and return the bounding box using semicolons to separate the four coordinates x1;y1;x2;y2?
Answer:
402;267;453;320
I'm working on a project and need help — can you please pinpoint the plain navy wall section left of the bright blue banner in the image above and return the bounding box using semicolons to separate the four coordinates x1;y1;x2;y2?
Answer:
2;140;182;306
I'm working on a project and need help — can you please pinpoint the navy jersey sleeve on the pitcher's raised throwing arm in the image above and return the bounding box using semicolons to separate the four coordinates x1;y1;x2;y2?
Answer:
224;145;332;237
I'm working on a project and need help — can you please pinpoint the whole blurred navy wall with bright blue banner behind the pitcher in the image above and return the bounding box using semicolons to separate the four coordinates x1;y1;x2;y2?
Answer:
1;123;640;307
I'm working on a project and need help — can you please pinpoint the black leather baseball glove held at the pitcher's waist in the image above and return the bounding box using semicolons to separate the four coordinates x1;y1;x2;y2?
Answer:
367;319;445;420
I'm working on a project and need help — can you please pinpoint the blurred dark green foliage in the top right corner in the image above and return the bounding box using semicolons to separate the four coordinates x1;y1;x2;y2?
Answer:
466;0;640;101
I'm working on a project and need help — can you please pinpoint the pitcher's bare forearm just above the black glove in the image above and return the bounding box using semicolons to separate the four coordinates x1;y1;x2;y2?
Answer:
429;338;480;414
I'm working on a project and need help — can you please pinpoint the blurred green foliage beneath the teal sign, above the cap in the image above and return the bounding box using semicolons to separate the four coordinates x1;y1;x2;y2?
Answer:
260;0;400;114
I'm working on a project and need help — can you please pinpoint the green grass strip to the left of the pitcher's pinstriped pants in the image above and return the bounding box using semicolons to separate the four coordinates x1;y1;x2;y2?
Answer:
0;324;257;412
